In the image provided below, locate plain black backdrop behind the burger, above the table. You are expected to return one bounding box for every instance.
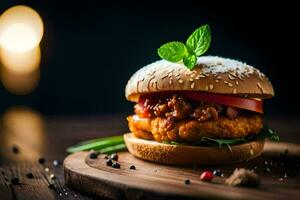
[0,0,300,115]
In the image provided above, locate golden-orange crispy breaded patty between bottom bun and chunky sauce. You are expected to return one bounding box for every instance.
[127,114,263,142]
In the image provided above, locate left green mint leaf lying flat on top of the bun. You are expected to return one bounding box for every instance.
[157,42,188,62]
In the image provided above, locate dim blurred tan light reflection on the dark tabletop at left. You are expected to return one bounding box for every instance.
[1,107,46,161]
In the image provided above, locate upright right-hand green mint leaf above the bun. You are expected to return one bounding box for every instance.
[186,24,211,56]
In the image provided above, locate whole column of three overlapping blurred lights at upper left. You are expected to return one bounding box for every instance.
[0,5,44,95]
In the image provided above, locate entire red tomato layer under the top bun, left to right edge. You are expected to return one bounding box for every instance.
[139,91,263,113]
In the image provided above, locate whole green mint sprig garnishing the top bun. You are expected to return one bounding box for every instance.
[157,24,211,70]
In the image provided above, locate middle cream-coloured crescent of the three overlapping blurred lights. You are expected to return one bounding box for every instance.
[0,46,41,74]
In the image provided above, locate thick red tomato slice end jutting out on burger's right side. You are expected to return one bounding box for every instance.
[180,91,264,113]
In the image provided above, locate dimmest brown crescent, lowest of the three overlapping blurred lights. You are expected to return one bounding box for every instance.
[1,64,40,95]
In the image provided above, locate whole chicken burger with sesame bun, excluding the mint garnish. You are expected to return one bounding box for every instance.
[124,56,274,165]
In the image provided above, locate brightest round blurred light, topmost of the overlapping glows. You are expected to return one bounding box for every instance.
[0,6,44,52]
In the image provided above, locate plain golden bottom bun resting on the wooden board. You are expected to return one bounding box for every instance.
[124,133,264,165]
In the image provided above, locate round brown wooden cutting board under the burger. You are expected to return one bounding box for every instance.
[64,145,300,199]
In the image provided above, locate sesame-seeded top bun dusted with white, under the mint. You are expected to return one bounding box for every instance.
[125,56,274,102]
